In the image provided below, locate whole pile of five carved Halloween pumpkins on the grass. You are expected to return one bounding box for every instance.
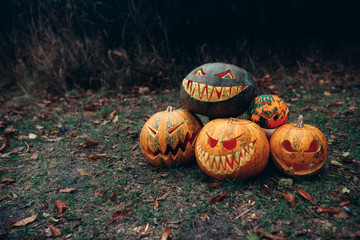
[140,63,328,180]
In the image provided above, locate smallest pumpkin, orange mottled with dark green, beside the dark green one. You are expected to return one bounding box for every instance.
[248,95,289,129]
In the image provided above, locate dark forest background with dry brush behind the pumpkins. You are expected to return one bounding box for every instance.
[0,0,360,94]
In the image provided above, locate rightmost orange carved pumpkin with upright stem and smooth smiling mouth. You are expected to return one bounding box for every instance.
[270,115,328,176]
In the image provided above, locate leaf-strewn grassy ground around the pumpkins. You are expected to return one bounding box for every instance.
[0,61,360,239]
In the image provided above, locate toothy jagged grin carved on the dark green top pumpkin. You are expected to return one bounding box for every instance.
[182,79,248,102]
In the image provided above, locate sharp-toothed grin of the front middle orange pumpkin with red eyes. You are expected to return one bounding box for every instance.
[195,140,256,174]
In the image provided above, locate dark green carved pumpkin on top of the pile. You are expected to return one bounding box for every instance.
[180,63,257,118]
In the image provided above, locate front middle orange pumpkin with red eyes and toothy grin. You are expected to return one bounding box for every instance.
[195,118,270,180]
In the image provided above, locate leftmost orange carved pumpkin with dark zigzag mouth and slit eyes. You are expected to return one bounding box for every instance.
[140,107,202,167]
